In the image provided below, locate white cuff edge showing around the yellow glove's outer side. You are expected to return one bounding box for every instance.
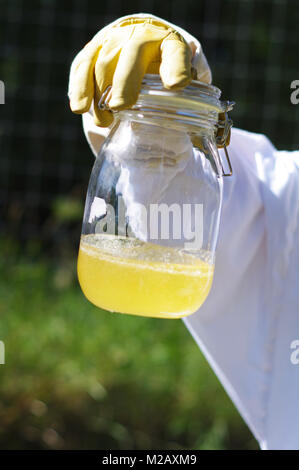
[82,13,212,156]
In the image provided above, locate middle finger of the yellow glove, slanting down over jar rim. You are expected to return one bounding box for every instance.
[109,40,159,110]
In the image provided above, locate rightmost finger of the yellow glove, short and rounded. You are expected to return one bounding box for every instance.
[160,31,192,89]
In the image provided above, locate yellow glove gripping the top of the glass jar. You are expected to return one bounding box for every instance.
[69,17,192,127]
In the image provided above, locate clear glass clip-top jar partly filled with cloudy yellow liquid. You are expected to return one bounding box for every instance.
[78,75,234,318]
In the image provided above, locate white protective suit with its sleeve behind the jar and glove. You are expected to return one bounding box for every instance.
[78,15,299,449]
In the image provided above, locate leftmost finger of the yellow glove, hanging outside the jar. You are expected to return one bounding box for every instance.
[69,38,101,114]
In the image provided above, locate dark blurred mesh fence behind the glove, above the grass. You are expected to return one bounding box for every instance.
[0,0,299,246]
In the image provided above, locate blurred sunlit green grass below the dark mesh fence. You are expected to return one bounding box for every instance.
[0,243,256,449]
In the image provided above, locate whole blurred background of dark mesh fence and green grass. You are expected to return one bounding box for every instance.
[0,0,299,449]
